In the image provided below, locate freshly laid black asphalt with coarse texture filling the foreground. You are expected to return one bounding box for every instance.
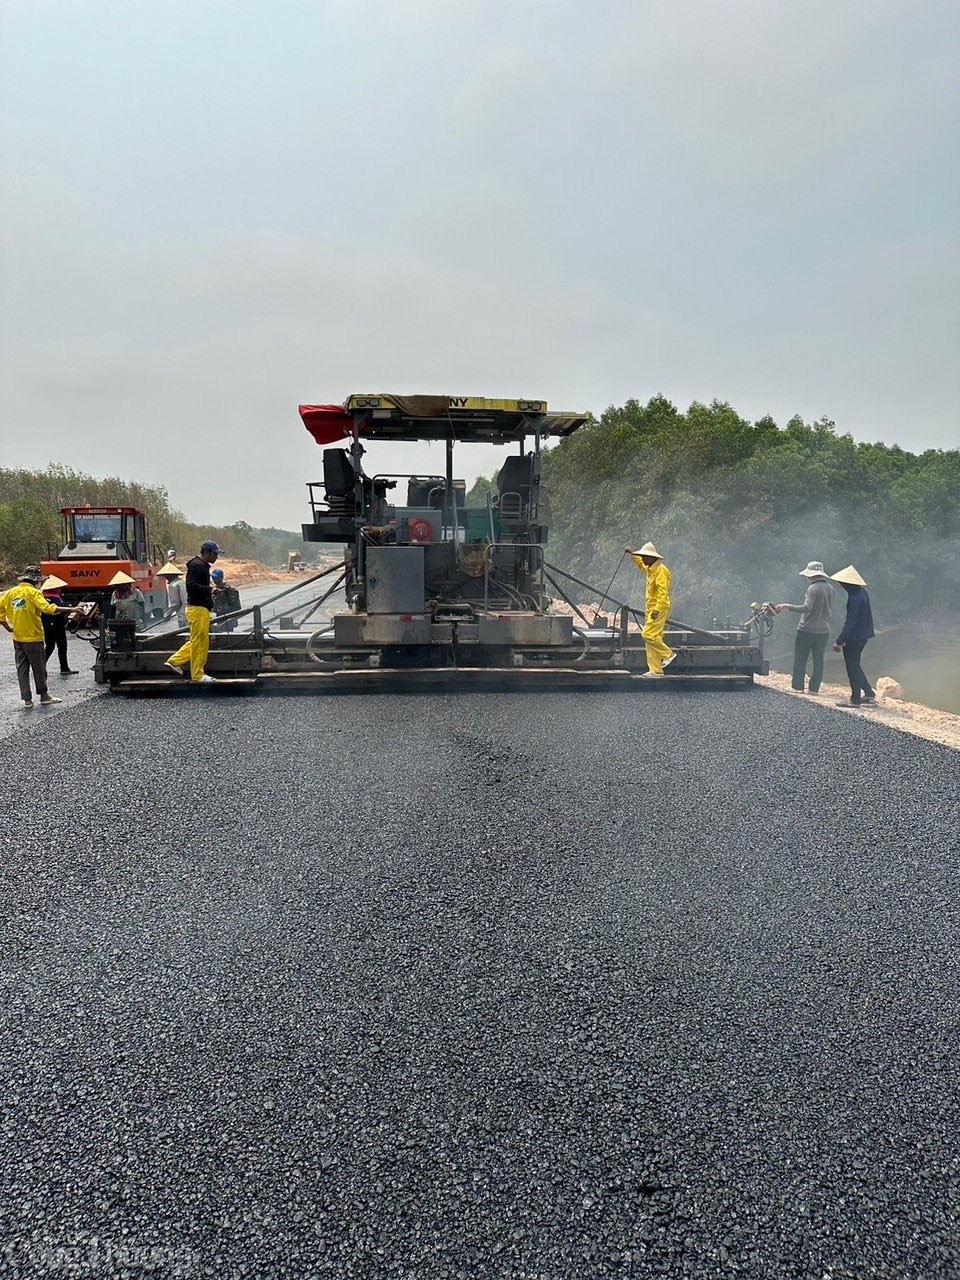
[0,687,960,1280]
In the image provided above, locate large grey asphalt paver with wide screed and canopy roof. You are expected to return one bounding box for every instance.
[97,394,767,692]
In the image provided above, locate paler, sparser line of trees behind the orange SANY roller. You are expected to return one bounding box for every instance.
[0,465,308,582]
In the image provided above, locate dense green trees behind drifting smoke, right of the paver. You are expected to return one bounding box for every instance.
[476,396,960,622]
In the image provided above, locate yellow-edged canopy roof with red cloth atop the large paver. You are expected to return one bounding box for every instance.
[300,396,589,444]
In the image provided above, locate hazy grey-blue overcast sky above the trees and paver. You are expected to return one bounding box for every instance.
[0,0,960,527]
